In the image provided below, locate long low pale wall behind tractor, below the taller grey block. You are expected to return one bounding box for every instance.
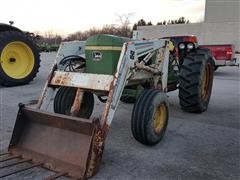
[138,22,240,49]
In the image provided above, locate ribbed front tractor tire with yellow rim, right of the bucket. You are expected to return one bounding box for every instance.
[131,89,168,145]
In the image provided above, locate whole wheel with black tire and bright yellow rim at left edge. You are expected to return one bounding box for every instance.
[0,31,40,86]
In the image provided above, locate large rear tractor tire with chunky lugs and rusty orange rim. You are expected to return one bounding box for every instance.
[179,49,214,113]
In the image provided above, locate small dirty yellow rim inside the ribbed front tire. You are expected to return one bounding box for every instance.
[153,104,167,134]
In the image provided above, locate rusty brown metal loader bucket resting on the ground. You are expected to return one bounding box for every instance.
[9,106,103,179]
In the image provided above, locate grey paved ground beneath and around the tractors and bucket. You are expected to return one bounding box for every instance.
[0,53,240,180]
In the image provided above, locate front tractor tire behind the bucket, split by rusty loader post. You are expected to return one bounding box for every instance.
[53,87,94,119]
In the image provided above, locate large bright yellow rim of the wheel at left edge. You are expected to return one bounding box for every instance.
[0,41,34,79]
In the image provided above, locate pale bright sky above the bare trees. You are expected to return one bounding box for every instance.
[0,0,205,35]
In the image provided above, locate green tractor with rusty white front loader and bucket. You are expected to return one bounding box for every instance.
[3,35,213,179]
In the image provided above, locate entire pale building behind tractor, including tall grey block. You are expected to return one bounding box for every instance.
[138,0,240,51]
